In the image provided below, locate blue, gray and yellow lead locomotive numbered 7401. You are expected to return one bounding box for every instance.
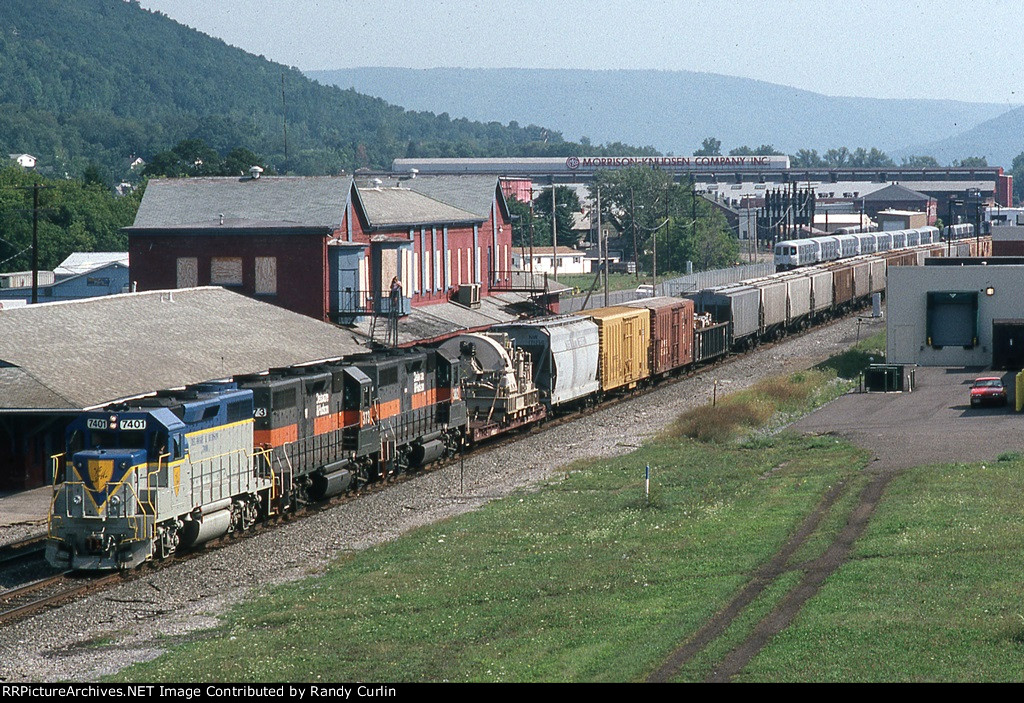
[46,383,274,569]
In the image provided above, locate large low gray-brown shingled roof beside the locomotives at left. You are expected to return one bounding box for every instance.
[0,288,366,408]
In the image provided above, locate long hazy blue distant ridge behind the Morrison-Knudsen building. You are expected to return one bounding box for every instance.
[304,68,1021,166]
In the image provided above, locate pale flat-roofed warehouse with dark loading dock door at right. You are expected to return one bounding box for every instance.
[886,258,1024,368]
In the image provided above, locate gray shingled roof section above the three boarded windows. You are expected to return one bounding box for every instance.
[128,176,352,230]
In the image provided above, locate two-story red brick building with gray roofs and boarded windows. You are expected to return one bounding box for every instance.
[125,175,512,322]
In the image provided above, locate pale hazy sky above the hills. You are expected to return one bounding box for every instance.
[141,0,1024,104]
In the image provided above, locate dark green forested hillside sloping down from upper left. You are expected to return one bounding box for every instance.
[0,0,653,182]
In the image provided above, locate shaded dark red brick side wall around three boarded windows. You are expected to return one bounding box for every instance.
[128,233,328,320]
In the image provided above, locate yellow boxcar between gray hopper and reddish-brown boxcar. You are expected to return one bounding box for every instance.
[587,306,650,392]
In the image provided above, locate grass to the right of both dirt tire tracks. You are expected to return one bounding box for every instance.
[741,458,1024,682]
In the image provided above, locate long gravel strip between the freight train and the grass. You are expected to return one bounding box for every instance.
[0,319,884,683]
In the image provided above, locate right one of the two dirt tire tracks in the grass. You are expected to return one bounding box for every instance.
[707,470,903,683]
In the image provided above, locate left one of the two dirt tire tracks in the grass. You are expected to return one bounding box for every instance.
[647,481,847,684]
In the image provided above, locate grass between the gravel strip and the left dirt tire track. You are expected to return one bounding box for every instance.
[114,438,863,680]
